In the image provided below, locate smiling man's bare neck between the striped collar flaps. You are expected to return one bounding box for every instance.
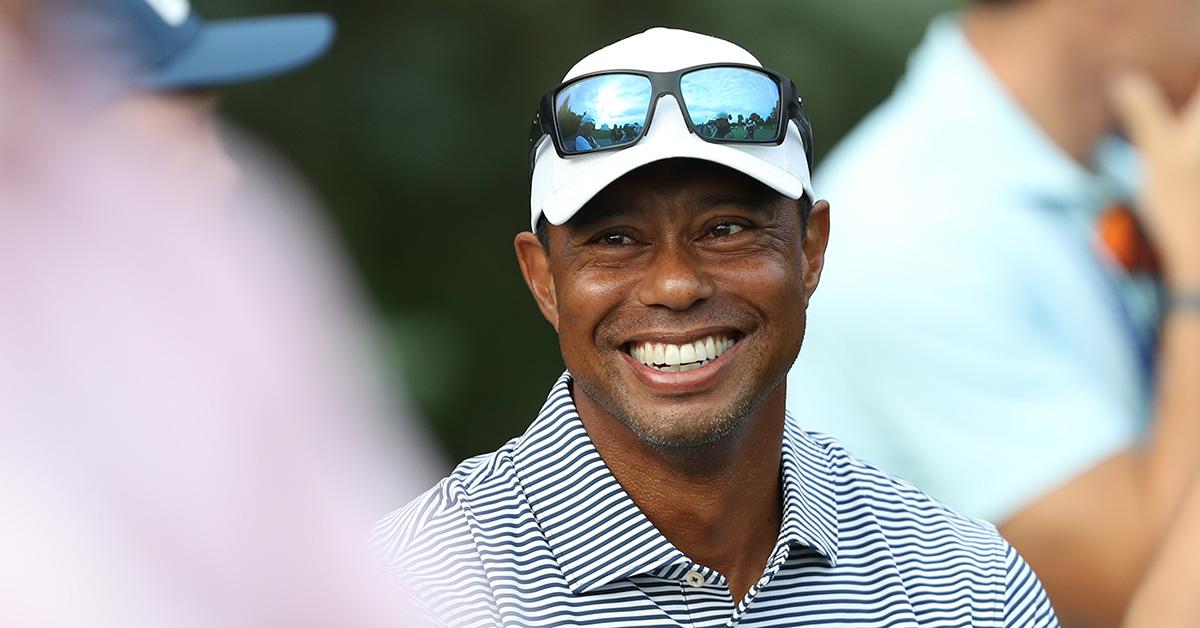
[575,384,785,602]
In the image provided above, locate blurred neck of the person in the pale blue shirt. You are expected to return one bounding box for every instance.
[962,2,1114,166]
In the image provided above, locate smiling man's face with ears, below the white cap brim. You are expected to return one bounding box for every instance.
[517,160,828,447]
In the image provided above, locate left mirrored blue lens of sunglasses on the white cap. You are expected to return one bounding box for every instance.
[554,74,650,155]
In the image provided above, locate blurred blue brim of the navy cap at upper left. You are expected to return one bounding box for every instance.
[143,13,336,89]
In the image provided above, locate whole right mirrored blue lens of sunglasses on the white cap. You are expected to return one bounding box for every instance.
[679,67,782,142]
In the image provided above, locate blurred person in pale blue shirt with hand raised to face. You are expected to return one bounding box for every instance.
[791,0,1200,626]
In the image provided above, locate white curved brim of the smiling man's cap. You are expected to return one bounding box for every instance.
[541,135,812,225]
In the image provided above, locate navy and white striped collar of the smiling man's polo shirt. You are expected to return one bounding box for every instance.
[512,372,838,593]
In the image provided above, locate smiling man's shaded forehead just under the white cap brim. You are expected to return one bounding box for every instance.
[564,159,791,229]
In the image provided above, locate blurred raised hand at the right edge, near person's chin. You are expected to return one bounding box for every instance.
[1111,73,1200,292]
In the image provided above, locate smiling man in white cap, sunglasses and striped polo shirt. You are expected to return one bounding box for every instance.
[374,29,1056,627]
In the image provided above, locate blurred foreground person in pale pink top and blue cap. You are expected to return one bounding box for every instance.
[0,0,439,628]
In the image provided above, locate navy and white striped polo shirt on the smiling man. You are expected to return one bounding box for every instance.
[372,373,1057,627]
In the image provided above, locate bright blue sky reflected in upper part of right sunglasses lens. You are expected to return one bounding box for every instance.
[679,67,779,124]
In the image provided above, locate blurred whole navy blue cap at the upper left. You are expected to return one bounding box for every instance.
[60,0,335,90]
